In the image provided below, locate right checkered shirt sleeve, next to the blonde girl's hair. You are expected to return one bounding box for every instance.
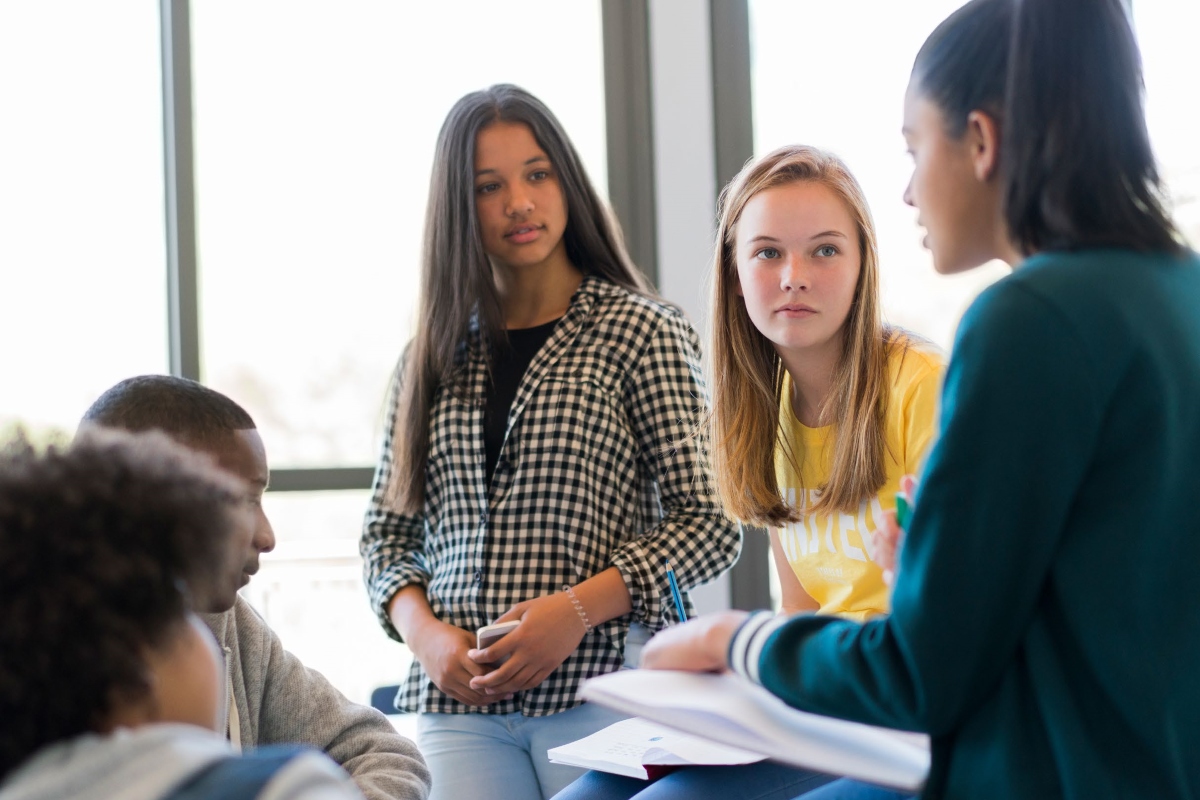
[612,313,742,630]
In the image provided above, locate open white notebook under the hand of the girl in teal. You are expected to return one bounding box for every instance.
[576,669,929,792]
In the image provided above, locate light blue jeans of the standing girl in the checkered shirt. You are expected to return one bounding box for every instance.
[416,703,626,800]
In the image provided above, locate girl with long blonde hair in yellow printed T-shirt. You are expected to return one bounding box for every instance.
[559,146,942,800]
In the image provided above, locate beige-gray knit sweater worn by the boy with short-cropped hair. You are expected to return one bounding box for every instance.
[238,606,430,800]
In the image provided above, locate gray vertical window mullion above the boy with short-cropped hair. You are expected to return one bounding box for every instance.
[158,0,200,380]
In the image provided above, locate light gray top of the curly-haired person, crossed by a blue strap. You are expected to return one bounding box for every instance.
[0,723,362,800]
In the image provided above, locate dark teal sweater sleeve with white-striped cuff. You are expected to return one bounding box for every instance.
[748,281,1103,735]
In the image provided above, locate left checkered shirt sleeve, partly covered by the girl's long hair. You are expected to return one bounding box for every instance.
[359,350,430,642]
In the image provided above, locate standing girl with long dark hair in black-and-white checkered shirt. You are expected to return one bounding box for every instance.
[361,85,740,800]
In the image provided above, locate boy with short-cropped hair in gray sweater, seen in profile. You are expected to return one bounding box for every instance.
[80,375,430,800]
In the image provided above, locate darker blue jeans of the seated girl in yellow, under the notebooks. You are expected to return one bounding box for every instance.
[554,762,833,800]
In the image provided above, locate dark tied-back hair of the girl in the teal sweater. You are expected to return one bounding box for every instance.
[912,0,1182,254]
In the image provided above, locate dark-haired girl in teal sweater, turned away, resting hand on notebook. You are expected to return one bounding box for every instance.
[643,0,1200,799]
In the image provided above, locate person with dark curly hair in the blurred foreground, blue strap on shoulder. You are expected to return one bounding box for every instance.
[0,432,361,800]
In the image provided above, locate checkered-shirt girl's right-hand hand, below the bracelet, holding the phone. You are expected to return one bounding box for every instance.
[467,591,586,696]
